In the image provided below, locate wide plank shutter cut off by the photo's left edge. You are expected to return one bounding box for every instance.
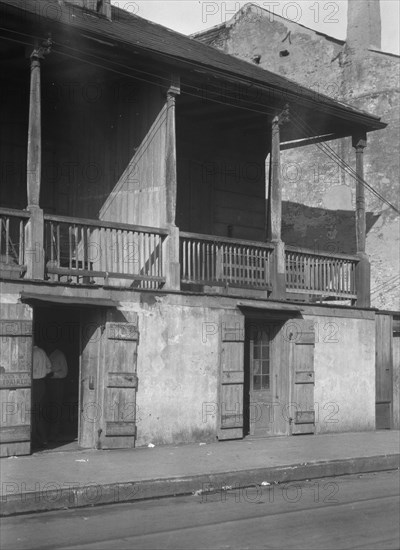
[0,304,33,457]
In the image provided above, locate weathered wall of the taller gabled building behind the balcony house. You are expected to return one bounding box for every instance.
[195,4,400,310]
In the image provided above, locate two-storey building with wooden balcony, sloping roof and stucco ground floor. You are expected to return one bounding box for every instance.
[0,0,399,456]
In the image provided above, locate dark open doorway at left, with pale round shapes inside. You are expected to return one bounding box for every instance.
[32,304,80,451]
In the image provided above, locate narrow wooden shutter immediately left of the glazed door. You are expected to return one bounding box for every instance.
[218,315,244,439]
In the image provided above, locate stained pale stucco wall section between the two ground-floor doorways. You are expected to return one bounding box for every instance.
[122,298,223,446]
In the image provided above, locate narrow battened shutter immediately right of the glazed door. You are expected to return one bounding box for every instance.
[287,319,315,435]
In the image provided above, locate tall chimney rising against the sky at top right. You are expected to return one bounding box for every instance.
[347,0,381,53]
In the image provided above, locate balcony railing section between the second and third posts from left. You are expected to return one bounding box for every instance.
[180,233,273,289]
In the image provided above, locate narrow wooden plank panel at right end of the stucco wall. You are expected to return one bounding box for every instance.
[375,315,393,430]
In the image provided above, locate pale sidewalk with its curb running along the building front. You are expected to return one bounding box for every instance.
[0,431,400,515]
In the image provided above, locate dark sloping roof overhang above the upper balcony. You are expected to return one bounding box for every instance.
[0,0,386,140]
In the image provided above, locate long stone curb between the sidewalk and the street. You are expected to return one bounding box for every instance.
[0,454,400,517]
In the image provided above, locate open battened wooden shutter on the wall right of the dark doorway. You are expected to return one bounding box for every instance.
[100,321,139,449]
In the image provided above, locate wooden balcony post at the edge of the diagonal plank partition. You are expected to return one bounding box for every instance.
[164,75,180,290]
